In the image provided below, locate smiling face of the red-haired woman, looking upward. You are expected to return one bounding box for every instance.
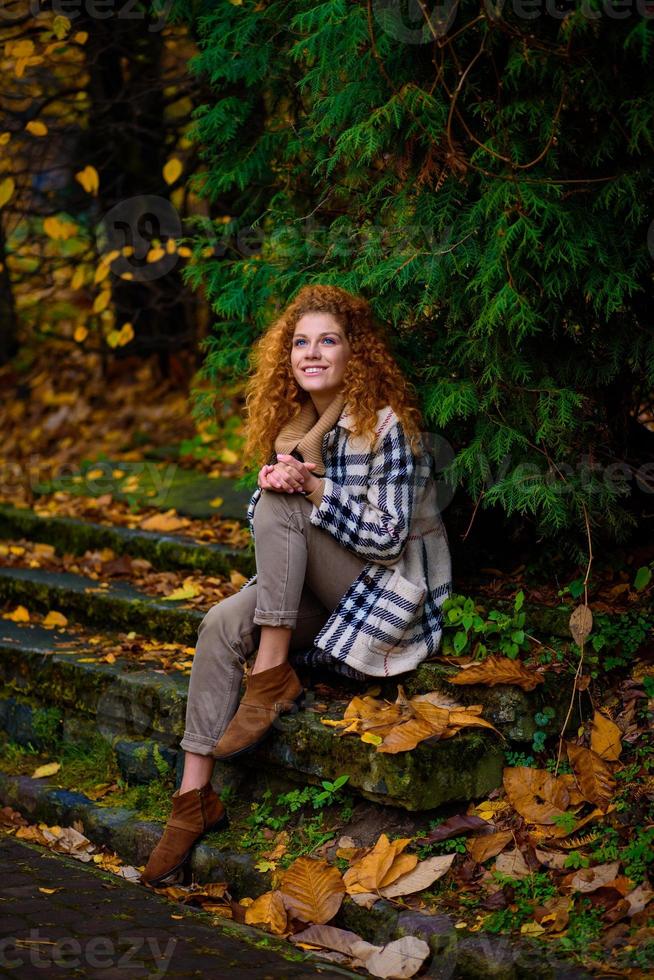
[291,313,352,411]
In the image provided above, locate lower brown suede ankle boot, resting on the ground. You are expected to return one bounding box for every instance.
[141,782,227,888]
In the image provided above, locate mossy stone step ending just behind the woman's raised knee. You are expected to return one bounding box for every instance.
[0,504,256,578]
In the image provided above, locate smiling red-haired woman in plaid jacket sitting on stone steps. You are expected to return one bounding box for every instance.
[141,286,451,885]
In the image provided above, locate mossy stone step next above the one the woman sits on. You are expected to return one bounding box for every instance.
[0,568,204,646]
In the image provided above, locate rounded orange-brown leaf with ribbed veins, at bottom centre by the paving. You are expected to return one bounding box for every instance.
[279,857,345,925]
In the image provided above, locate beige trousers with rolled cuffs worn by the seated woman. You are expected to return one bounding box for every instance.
[179,490,366,755]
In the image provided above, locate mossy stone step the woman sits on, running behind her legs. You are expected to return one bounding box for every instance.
[0,621,507,810]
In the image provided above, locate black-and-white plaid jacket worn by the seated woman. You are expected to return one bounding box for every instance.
[242,405,452,677]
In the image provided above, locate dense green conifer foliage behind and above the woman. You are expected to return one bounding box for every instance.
[174,0,654,538]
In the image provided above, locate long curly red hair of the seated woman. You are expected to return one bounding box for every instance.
[244,285,422,467]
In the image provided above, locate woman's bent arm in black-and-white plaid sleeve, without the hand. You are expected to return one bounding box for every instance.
[310,423,416,565]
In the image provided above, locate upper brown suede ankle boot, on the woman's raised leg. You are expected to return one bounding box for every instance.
[211,661,304,759]
